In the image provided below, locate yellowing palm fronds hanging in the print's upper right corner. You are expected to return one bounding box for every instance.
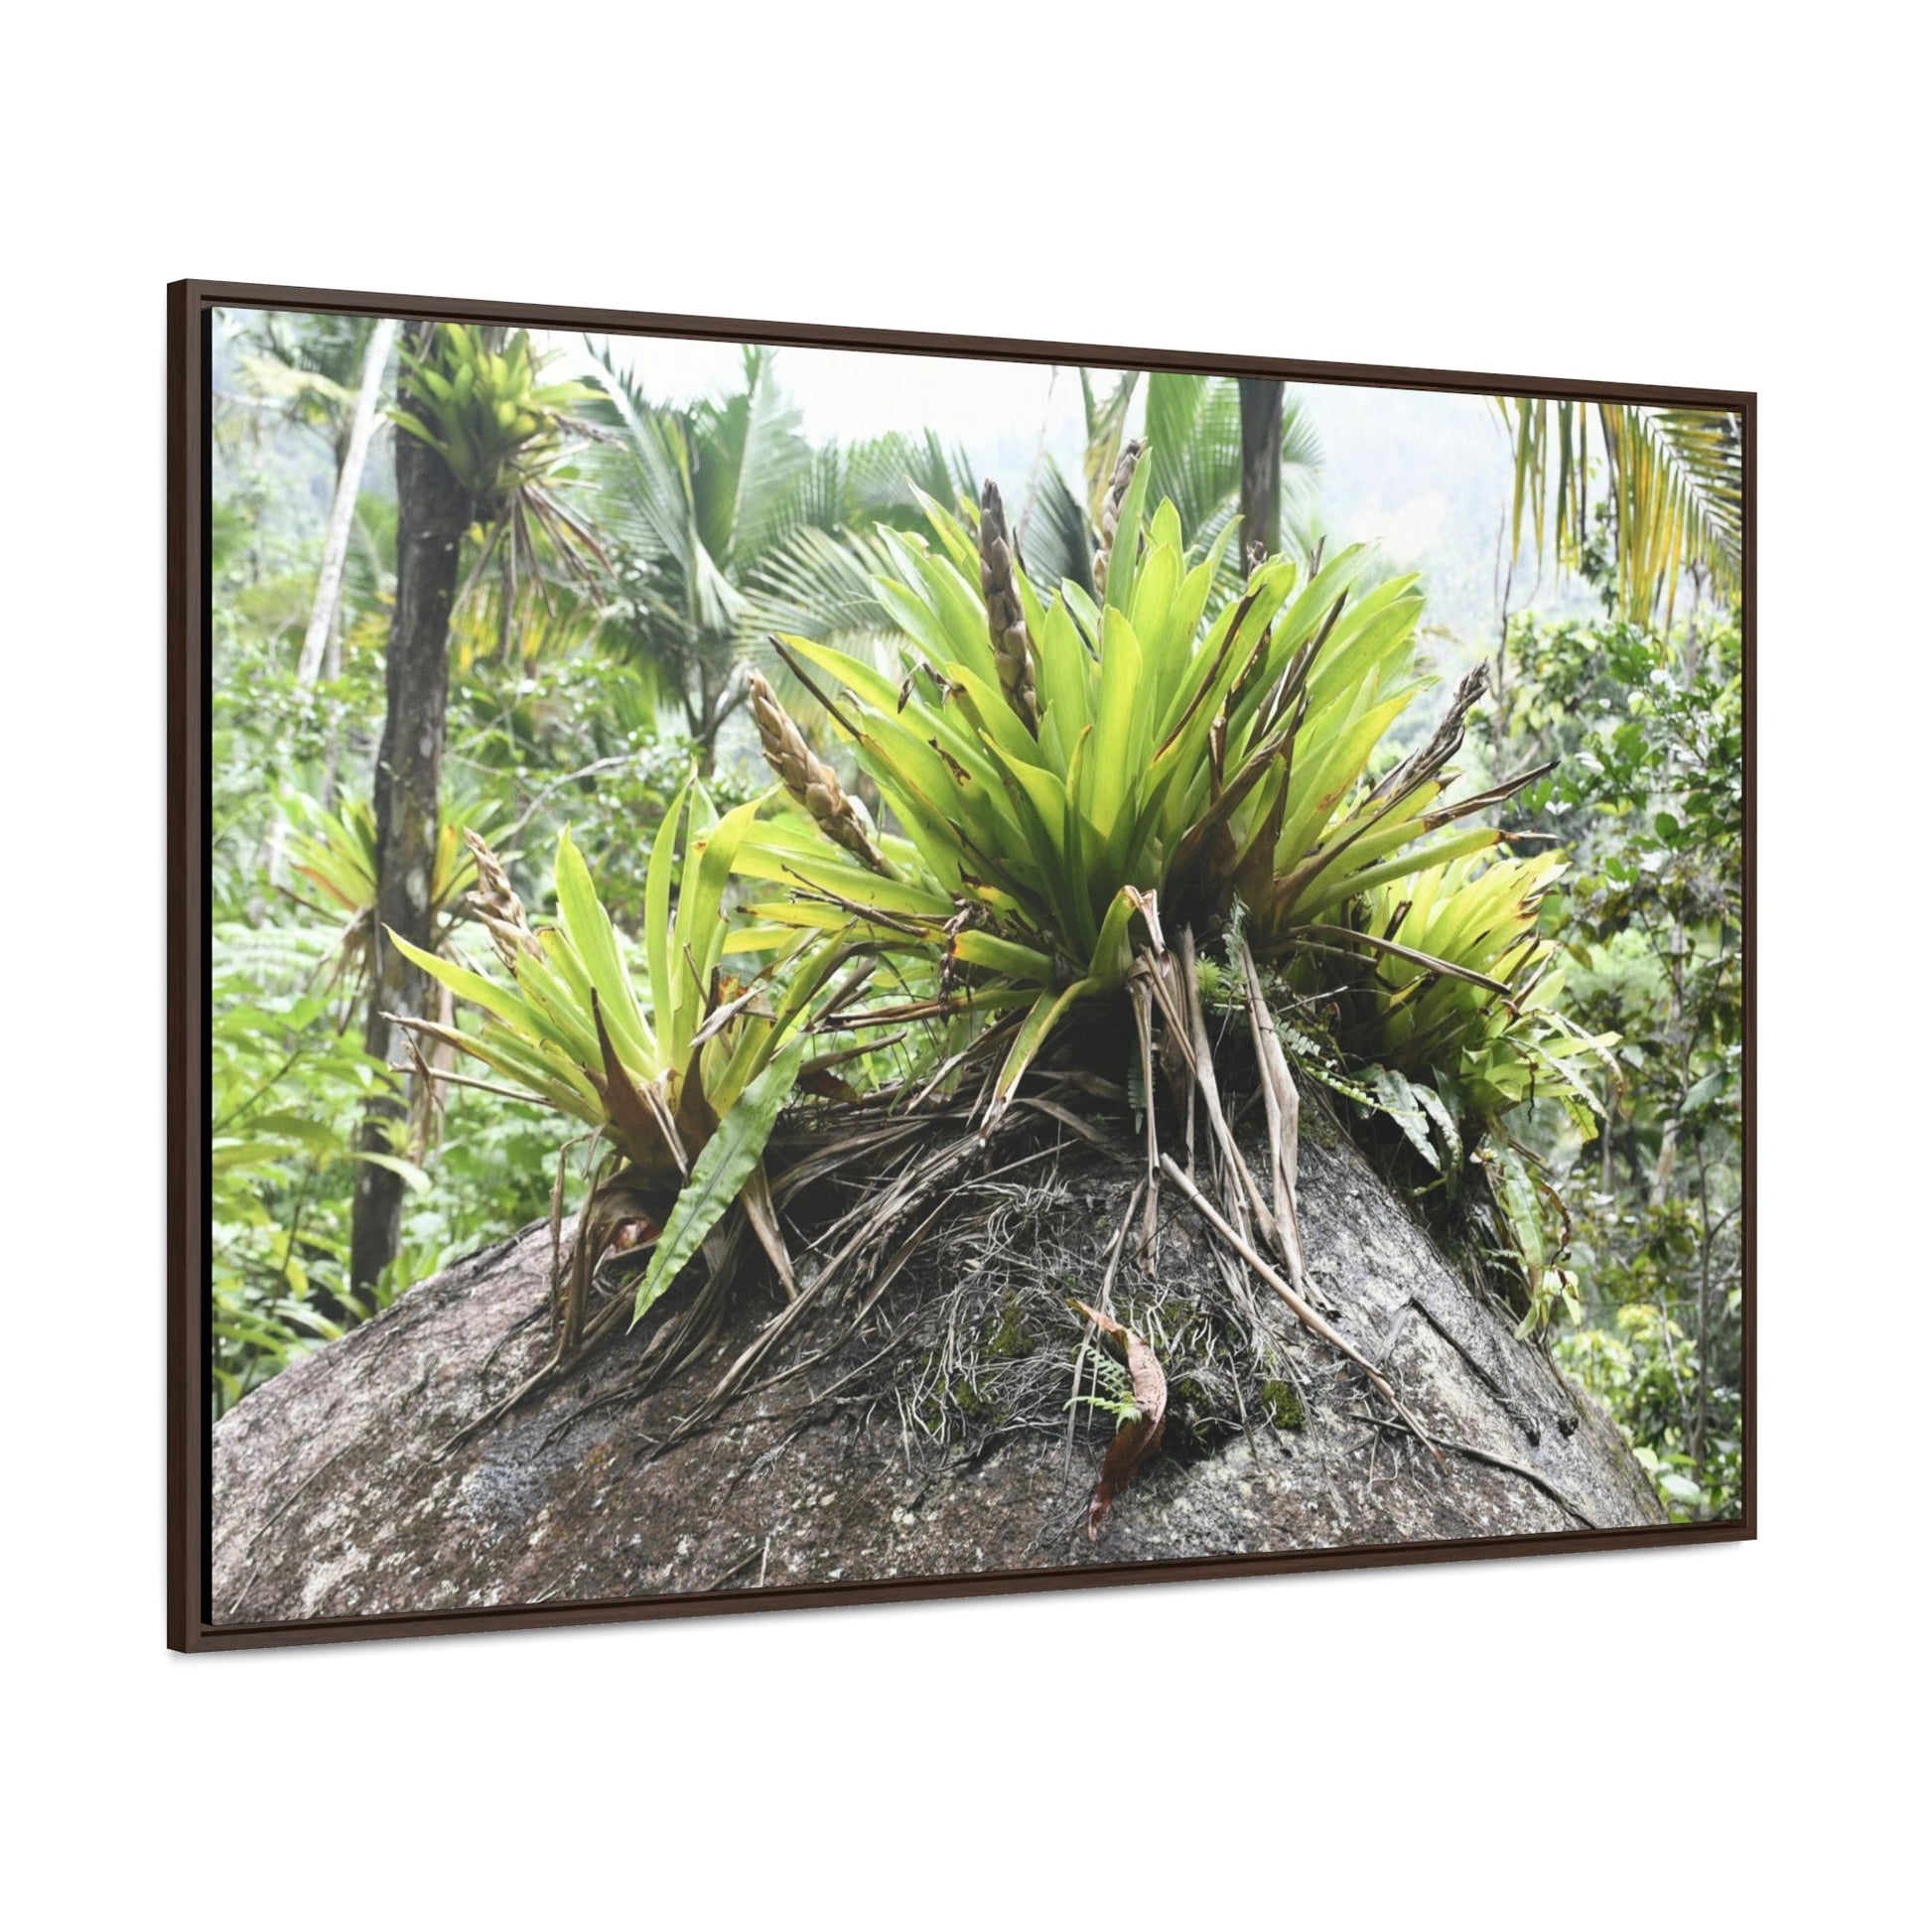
[1497,396,1744,626]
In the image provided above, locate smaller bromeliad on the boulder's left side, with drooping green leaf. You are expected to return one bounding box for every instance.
[390,782,839,1428]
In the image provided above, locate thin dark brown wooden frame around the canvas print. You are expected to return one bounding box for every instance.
[166,280,1758,1652]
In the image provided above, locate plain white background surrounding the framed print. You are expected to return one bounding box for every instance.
[0,0,1932,1928]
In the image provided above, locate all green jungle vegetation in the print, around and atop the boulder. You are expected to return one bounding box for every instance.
[210,315,1744,1526]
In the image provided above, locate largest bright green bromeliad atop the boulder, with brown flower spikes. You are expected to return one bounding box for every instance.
[740,445,1538,1127]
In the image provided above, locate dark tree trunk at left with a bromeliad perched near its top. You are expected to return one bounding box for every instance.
[349,338,472,1287]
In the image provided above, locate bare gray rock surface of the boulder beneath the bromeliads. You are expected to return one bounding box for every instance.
[212,1140,1664,1623]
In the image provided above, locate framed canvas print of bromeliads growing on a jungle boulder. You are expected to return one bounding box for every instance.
[168,282,1754,1650]
